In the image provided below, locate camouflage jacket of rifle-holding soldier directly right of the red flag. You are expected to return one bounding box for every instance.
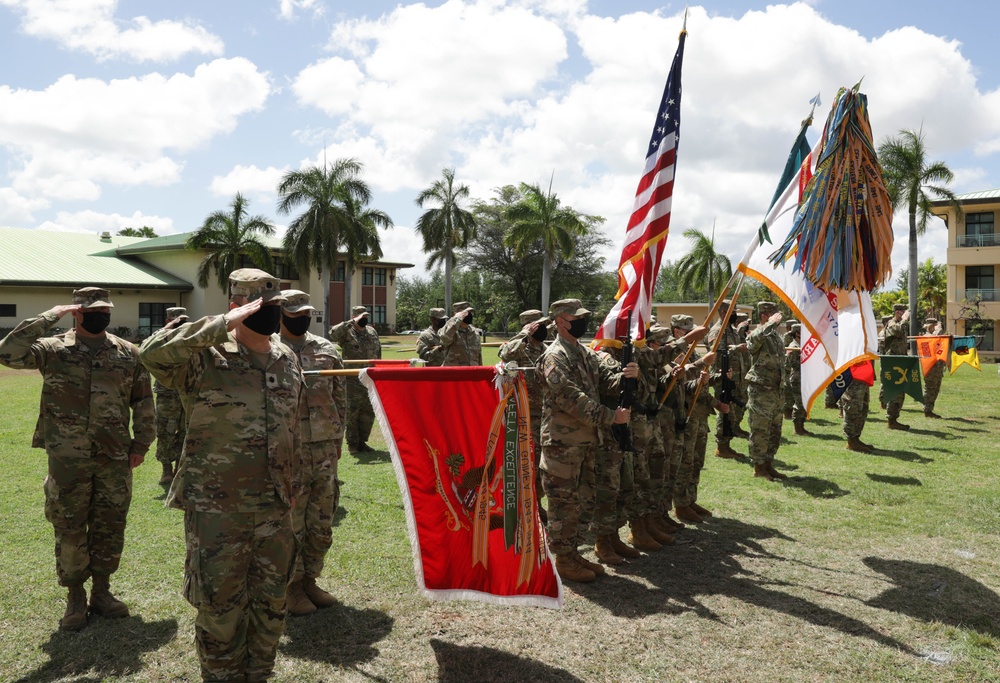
[535,337,621,446]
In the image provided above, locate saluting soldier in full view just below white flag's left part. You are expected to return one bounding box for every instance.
[747,301,787,481]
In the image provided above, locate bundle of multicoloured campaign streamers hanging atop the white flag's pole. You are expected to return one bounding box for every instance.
[768,83,893,291]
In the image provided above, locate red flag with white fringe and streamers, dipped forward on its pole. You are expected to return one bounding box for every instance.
[360,367,563,608]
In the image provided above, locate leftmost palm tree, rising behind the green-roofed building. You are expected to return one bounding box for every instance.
[187,192,274,292]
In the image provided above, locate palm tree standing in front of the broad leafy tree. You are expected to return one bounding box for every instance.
[504,180,586,311]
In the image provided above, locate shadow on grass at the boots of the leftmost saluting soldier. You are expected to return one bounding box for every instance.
[15,616,177,683]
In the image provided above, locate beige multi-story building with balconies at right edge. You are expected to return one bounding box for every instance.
[931,189,1000,358]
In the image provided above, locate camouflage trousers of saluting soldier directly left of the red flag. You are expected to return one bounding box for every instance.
[292,440,341,580]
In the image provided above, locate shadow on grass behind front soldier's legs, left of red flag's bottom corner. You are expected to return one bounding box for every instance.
[278,602,394,675]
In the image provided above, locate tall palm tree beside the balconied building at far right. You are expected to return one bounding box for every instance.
[878,129,962,344]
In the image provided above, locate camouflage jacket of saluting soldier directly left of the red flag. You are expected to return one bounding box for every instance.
[279,332,348,443]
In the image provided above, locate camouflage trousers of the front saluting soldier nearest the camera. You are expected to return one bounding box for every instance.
[184,505,295,681]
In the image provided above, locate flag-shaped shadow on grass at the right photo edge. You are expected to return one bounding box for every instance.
[864,557,1000,637]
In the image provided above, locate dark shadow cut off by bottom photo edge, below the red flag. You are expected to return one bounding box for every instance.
[431,638,583,683]
